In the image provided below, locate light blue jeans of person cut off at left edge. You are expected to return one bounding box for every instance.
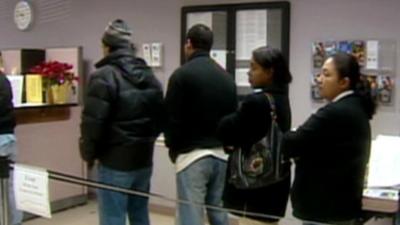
[0,134,23,225]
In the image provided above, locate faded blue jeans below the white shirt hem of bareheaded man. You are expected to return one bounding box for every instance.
[176,157,229,225]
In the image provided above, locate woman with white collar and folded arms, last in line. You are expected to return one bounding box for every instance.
[282,53,376,225]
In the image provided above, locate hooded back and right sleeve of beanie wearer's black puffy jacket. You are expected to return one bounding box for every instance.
[93,50,164,170]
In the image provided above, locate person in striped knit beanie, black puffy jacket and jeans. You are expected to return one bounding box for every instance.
[81,20,164,225]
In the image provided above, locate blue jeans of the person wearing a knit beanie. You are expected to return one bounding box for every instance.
[97,165,152,225]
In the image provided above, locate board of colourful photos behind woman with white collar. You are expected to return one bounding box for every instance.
[310,39,397,107]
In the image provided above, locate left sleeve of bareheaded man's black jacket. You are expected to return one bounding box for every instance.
[164,72,185,149]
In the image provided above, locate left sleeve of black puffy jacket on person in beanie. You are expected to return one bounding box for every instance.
[80,75,115,162]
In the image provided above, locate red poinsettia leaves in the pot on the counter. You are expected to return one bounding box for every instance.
[29,61,78,85]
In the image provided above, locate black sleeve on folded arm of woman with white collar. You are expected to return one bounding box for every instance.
[282,106,335,158]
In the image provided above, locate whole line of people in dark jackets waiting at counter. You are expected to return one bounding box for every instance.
[0,19,376,225]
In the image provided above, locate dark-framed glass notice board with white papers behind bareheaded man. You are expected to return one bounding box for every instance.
[181,1,290,96]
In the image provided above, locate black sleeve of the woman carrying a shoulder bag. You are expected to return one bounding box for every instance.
[217,96,271,146]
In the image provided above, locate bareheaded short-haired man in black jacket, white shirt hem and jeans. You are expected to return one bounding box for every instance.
[165,25,237,225]
